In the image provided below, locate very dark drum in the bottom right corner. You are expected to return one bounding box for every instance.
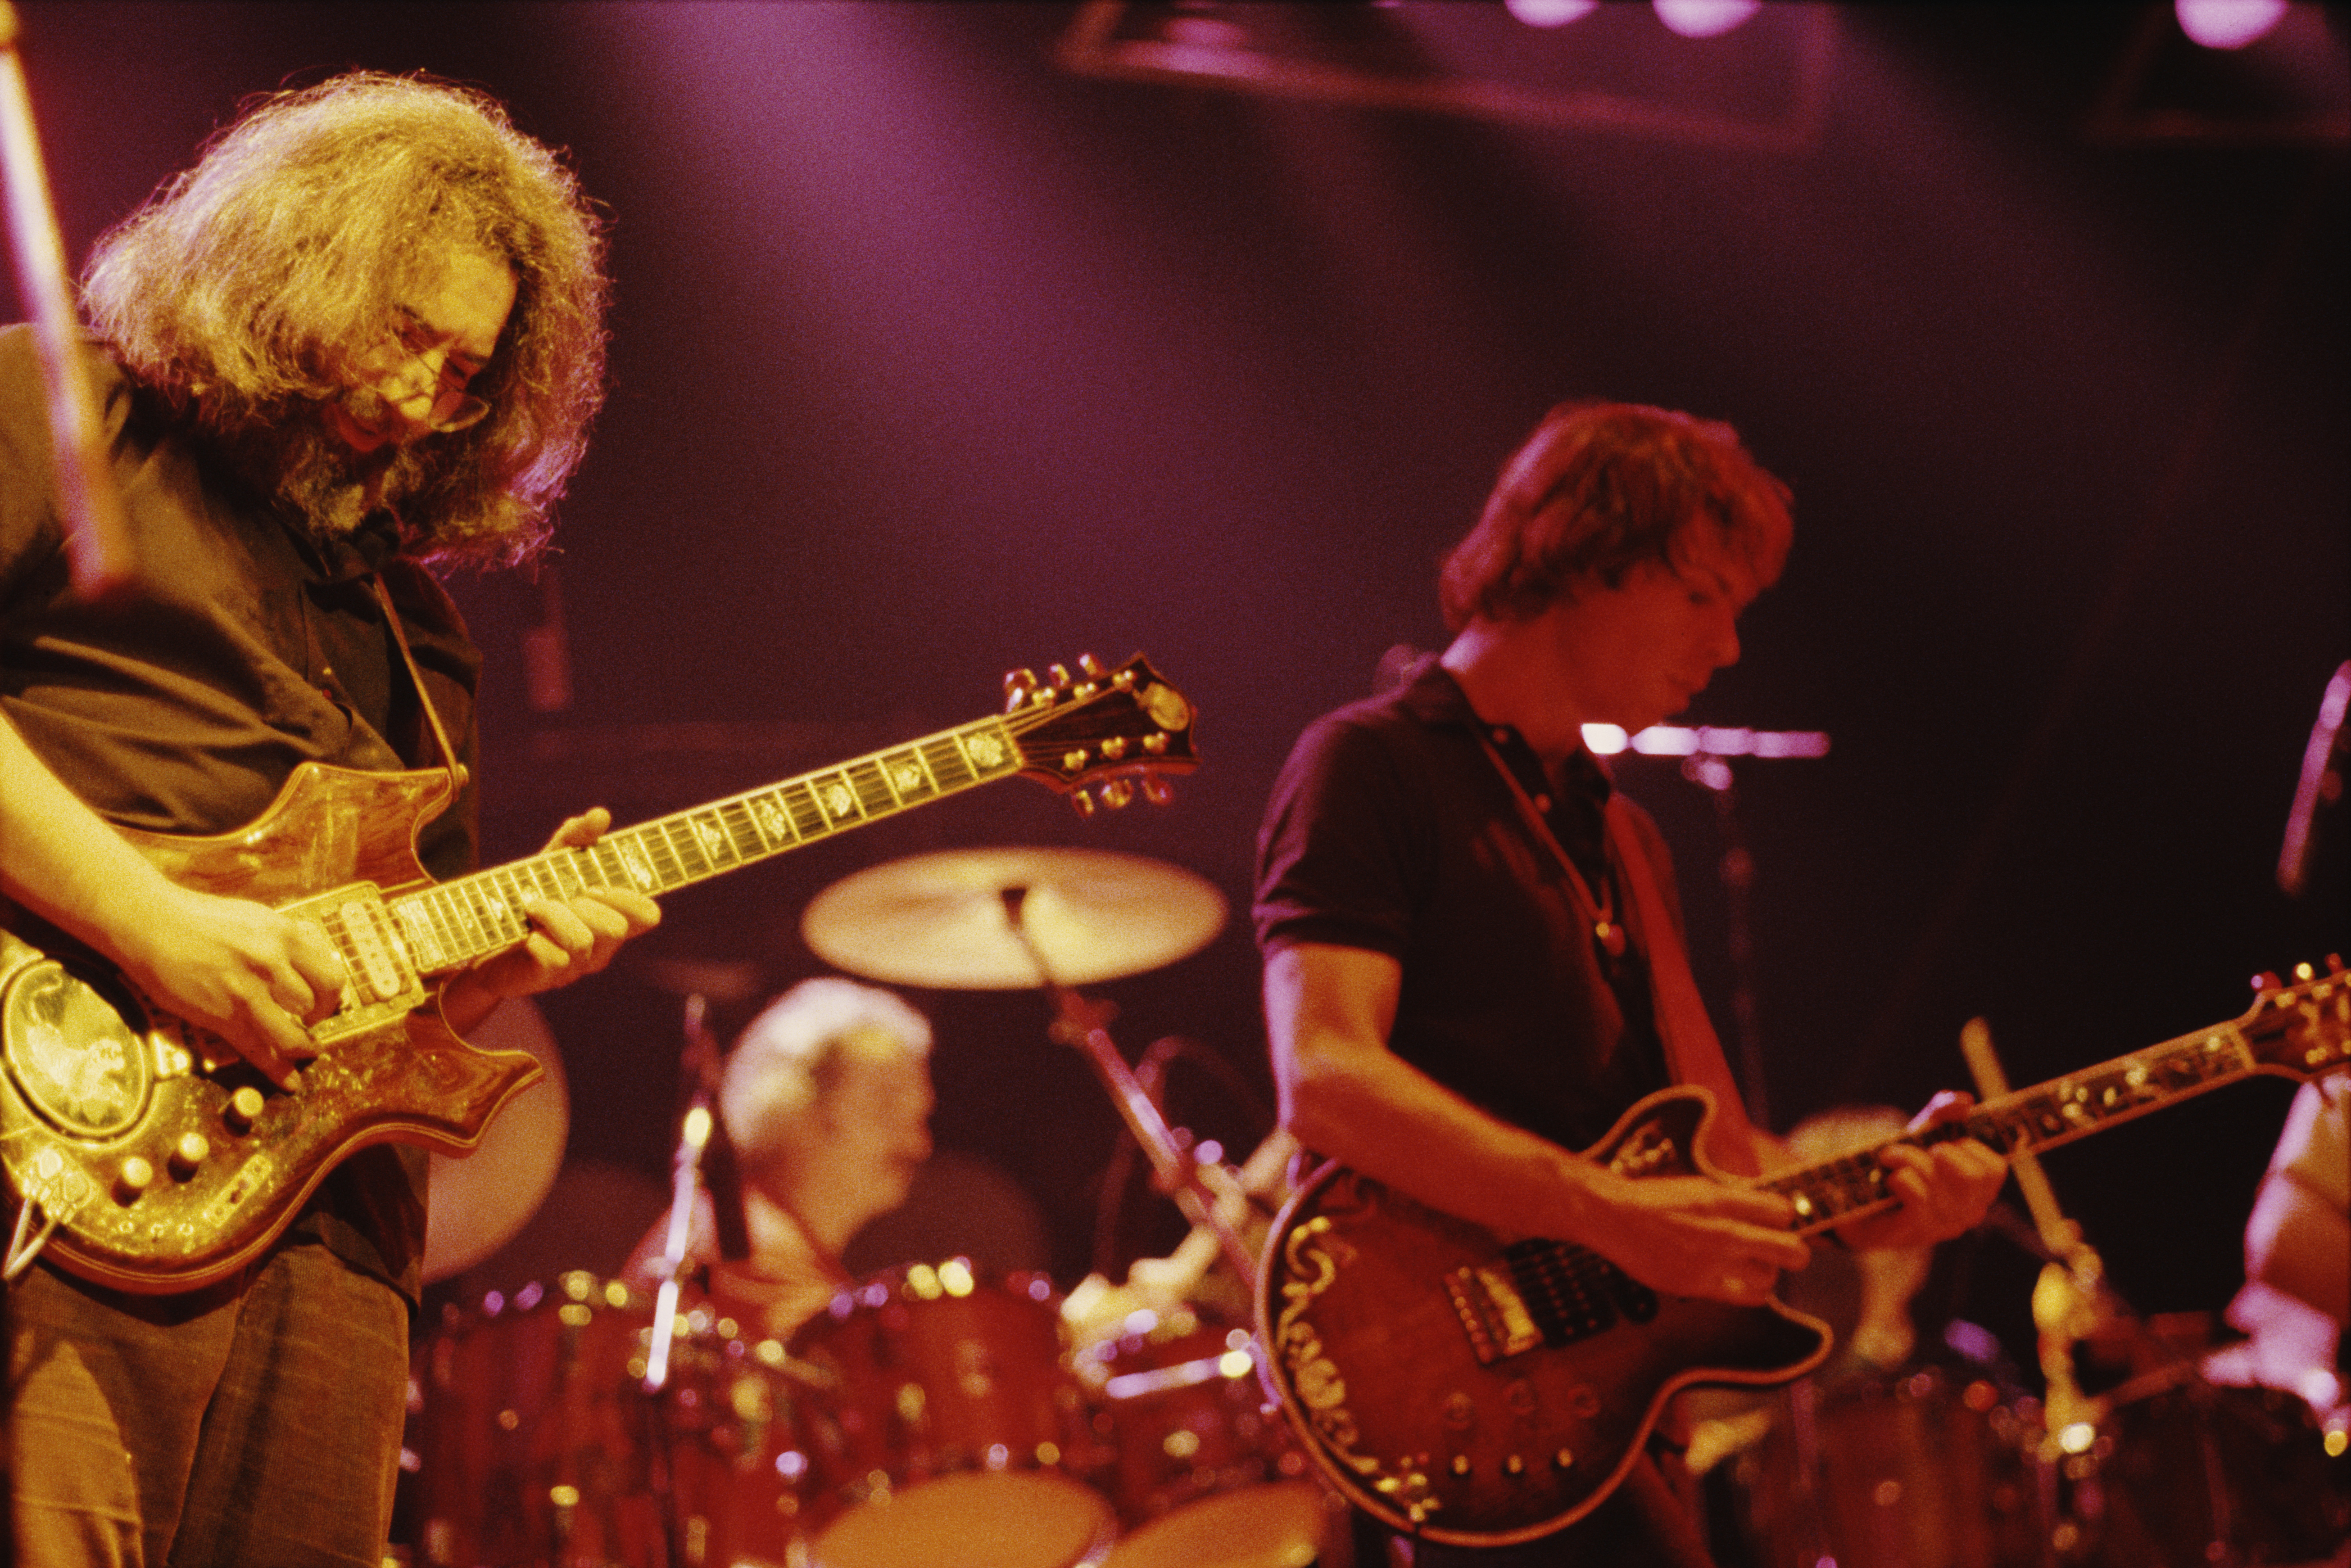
[2060,1382,2351,1568]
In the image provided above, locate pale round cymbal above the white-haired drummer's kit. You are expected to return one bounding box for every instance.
[799,846,1225,990]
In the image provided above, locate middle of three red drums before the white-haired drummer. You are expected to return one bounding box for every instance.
[780,1258,1114,1568]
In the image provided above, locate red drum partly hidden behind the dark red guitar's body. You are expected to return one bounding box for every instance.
[1077,1307,1333,1568]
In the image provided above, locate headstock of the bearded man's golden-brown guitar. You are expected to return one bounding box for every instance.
[1004,654,1199,816]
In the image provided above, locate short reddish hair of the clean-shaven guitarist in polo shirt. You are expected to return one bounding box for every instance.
[1439,402,1794,633]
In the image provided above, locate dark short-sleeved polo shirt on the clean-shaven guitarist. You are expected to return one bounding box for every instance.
[1255,658,1679,1150]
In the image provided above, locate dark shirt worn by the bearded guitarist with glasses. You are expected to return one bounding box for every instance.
[0,327,480,1300]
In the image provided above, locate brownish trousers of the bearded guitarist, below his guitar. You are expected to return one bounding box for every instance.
[7,1241,409,1568]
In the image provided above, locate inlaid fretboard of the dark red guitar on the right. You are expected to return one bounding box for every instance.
[1756,1023,2255,1234]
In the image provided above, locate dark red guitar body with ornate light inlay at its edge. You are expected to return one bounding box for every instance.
[1258,1089,1829,1547]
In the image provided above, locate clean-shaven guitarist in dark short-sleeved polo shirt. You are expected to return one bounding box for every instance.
[1255,402,2006,1568]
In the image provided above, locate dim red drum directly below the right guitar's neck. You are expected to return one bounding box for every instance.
[1733,1366,2047,1568]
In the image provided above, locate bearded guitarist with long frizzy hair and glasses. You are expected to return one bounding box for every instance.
[0,73,656,1568]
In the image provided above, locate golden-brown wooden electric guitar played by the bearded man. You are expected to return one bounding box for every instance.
[0,656,1196,1293]
